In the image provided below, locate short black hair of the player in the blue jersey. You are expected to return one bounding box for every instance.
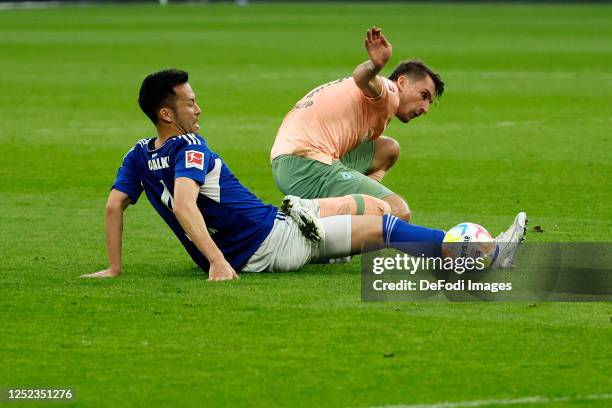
[138,69,189,125]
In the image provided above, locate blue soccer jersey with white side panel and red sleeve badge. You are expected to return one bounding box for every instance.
[113,134,278,270]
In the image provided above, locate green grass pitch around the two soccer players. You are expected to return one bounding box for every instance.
[0,4,612,407]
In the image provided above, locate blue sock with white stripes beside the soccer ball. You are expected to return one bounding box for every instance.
[383,214,445,257]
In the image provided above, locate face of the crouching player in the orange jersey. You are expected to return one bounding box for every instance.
[395,75,436,123]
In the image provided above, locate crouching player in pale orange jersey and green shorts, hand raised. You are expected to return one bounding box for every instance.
[271,27,444,221]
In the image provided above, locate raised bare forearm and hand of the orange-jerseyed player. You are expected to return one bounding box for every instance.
[353,27,392,98]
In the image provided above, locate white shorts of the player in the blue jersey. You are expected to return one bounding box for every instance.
[242,215,351,272]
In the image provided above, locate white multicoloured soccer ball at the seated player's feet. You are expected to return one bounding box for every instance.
[442,222,497,267]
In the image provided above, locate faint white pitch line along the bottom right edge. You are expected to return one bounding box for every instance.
[372,394,612,408]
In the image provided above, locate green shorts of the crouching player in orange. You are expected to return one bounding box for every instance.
[272,151,395,199]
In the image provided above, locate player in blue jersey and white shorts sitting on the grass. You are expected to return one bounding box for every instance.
[83,69,526,281]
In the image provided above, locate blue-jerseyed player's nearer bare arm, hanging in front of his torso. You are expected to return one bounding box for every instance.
[173,177,239,281]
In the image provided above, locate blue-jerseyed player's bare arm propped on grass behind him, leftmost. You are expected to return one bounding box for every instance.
[81,189,131,278]
